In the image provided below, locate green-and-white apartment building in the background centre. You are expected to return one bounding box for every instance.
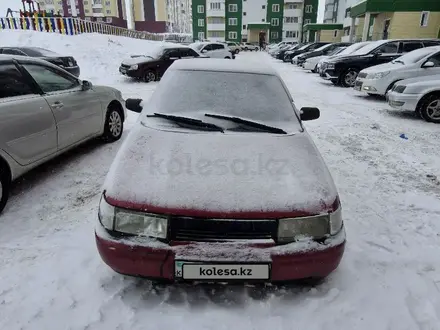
[192,0,318,42]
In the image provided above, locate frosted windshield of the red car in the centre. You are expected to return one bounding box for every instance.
[144,70,301,130]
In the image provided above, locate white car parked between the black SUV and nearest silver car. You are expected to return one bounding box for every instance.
[354,46,440,96]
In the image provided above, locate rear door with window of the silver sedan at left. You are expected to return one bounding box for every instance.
[0,61,57,166]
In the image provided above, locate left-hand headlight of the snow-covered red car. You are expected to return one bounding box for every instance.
[98,195,168,239]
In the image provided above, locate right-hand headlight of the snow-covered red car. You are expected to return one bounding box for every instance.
[278,206,343,243]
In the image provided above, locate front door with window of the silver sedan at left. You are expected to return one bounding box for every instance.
[21,63,104,150]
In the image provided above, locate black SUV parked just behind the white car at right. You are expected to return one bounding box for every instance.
[320,39,440,87]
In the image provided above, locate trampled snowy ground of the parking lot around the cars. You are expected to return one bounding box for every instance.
[0,31,440,330]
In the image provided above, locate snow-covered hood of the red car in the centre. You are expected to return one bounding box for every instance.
[103,121,337,217]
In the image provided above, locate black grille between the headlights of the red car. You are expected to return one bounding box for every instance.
[170,217,278,242]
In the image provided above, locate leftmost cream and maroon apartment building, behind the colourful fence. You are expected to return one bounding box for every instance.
[37,0,127,28]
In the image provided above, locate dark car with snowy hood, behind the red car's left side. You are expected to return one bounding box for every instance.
[119,45,207,82]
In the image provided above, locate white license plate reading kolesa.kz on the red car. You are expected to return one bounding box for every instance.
[175,261,270,281]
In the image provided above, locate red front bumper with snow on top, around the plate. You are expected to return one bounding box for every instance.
[95,224,345,282]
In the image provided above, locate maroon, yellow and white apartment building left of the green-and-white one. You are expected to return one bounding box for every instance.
[132,0,192,33]
